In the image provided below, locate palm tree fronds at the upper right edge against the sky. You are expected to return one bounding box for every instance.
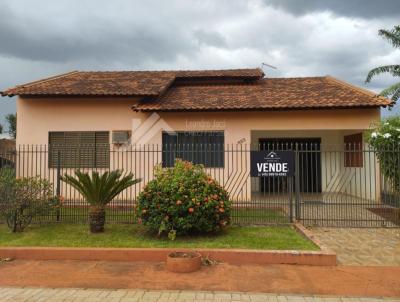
[365,25,400,103]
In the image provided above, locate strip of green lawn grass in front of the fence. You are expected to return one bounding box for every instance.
[0,223,318,250]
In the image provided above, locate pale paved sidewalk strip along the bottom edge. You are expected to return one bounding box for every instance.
[0,287,400,302]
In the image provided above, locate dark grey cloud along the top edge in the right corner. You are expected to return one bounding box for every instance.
[265,0,400,18]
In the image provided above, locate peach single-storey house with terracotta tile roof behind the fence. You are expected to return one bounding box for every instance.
[1,69,391,205]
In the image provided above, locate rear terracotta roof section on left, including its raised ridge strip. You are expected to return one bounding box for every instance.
[1,69,264,96]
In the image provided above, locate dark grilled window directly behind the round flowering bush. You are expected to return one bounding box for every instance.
[162,131,224,168]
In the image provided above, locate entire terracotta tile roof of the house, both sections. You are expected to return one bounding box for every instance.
[1,69,392,111]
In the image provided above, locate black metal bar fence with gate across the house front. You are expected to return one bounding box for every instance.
[0,142,400,227]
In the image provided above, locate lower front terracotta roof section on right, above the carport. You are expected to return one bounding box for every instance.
[133,76,391,111]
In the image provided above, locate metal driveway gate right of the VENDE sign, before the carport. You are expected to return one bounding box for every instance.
[295,145,400,227]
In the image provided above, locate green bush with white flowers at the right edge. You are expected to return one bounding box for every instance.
[367,116,400,192]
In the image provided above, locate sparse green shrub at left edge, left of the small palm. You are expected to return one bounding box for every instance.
[0,168,59,232]
